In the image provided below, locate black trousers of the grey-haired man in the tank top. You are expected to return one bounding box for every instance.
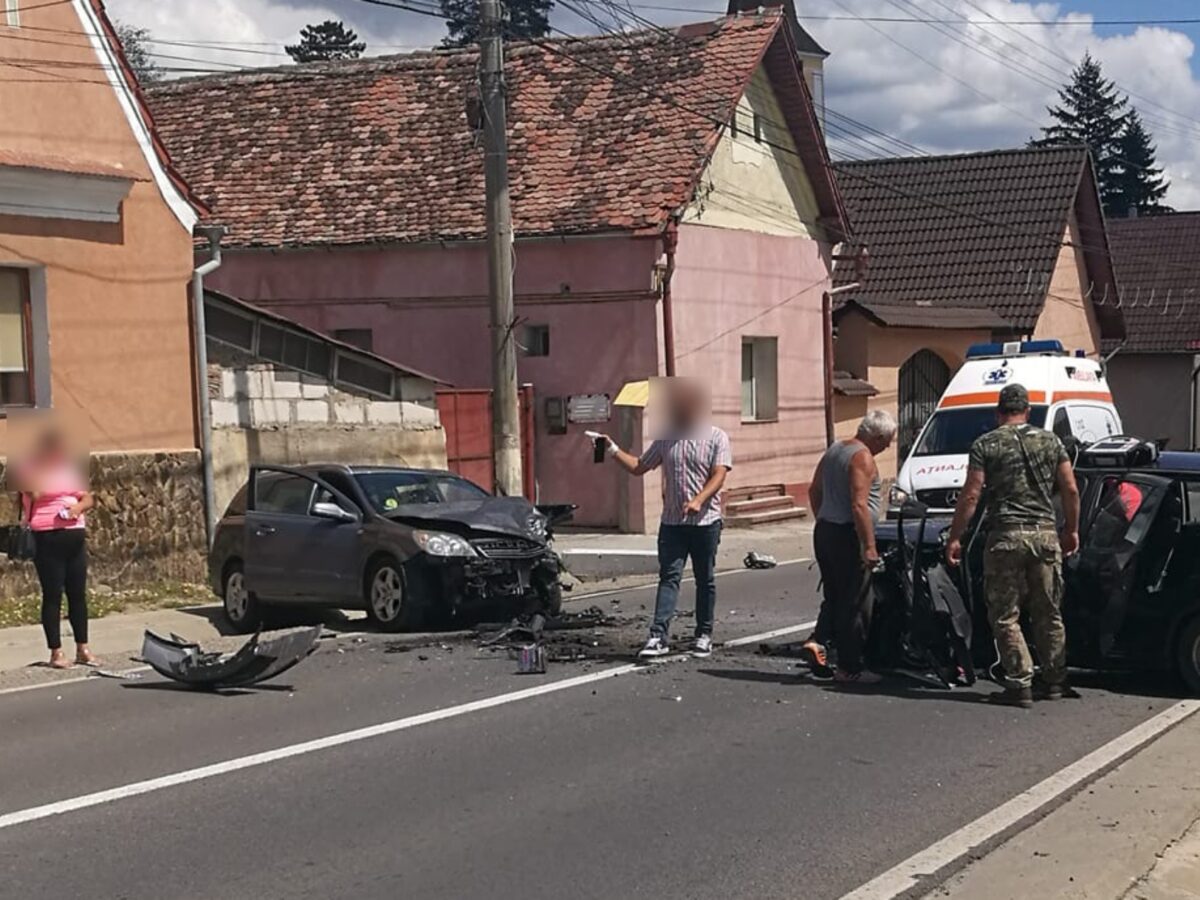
[812,522,871,672]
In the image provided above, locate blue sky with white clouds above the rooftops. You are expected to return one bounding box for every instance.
[107,0,1200,209]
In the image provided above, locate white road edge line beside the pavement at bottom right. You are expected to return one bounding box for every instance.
[841,700,1200,900]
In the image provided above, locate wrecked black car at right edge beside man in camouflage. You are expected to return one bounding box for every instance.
[875,438,1200,694]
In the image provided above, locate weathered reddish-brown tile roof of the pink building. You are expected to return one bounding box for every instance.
[142,11,841,252]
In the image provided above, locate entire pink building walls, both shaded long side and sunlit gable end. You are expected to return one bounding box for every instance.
[209,226,829,530]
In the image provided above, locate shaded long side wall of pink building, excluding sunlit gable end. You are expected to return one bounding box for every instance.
[209,238,661,528]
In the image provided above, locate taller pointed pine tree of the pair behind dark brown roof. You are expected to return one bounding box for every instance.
[1030,53,1129,215]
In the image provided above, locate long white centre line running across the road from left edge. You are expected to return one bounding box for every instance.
[0,625,805,830]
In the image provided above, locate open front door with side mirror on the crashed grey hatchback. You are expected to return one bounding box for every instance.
[245,466,362,602]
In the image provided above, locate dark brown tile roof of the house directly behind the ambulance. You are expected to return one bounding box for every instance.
[836,146,1120,335]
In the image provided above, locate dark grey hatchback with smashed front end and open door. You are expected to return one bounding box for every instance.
[209,466,574,631]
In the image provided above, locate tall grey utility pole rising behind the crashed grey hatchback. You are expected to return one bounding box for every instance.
[479,0,522,497]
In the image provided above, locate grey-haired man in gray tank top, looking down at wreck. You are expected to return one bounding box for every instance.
[804,409,896,684]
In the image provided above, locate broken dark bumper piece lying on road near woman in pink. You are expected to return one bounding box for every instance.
[142,625,320,690]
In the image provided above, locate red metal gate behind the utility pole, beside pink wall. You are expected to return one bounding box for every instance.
[438,384,538,500]
